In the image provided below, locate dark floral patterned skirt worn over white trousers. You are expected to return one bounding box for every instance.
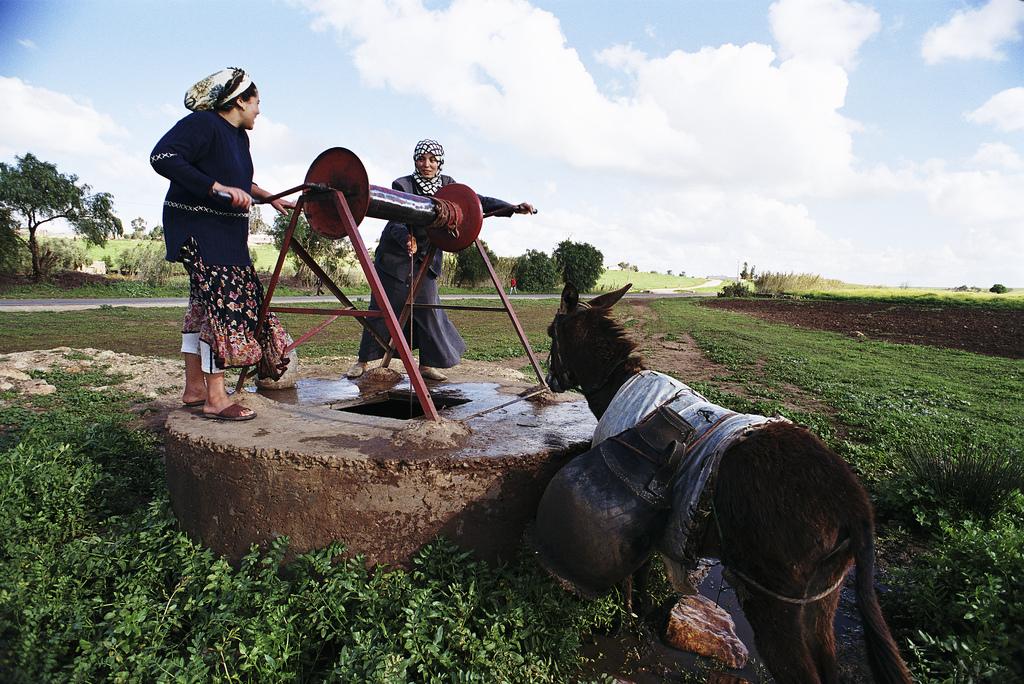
[178,239,292,380]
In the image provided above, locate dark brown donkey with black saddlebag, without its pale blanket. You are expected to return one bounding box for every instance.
[537,285,910,683]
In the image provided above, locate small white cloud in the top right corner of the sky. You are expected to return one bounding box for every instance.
[921,0,1024,65]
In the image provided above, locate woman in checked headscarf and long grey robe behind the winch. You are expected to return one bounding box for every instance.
[346,139,536,380]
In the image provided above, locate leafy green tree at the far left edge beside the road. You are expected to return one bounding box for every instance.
[0,153,124,281]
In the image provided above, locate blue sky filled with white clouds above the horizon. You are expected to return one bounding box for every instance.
[0,0,1024,288]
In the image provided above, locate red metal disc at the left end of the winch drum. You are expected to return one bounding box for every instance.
[303,147,370,240]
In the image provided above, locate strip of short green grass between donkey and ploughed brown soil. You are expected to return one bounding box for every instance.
[652,300,1024,464]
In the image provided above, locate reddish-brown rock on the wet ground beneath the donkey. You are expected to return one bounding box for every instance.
[665,594,750,669]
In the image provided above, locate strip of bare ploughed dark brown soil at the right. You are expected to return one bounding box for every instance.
[705,299,1024,358]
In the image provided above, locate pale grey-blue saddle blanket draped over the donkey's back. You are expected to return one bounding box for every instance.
[592,371,785,567]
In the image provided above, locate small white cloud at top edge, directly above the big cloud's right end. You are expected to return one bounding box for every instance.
[768,0,882,70]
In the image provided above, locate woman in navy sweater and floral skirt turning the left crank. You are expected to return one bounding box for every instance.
[150,69,294,421]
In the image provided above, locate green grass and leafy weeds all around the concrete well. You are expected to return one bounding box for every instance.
[0,300,1024,682]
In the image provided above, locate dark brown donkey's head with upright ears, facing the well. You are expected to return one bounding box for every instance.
[546,284,643,395]
